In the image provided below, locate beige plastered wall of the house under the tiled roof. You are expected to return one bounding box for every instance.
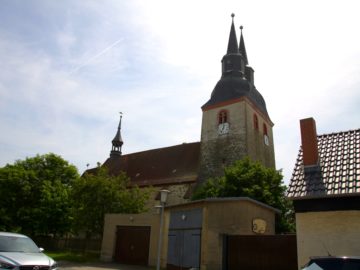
[296,211,360,269]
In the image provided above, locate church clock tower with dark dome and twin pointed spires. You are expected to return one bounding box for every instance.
[199,14,275,182]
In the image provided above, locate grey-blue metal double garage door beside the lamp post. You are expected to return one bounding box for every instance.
[167,209,202,270]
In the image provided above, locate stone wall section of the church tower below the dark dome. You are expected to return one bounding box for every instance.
[199,99,275,181]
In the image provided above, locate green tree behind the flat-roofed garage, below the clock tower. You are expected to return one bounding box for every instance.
[192,158,295,233]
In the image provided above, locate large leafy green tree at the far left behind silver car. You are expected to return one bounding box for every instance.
[0,153,79,235]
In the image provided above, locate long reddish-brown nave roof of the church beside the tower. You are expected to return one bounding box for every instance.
[103,142,200,186]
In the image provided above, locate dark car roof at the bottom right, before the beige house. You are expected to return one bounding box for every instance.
[302,256,360,270]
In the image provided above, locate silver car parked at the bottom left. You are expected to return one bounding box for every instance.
[0,232,57,270]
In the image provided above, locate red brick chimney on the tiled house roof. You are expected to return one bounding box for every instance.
[300,117,319,166]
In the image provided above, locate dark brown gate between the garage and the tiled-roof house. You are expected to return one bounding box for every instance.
[224,235,297,270]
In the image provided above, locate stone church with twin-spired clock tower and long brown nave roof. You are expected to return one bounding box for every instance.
[97,13,275,204]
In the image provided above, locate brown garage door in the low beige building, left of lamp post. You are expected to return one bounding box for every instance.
[115,226,150,265]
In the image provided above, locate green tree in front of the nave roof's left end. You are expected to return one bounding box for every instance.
[72,167,150,237]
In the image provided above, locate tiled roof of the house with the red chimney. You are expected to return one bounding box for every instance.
[287,129,360,199]
